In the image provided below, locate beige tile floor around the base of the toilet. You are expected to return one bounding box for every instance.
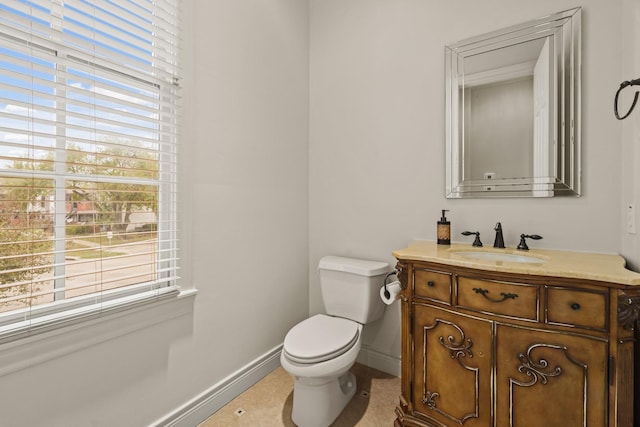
[199,363,400,427]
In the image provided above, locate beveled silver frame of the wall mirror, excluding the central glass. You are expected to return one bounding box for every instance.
[445,7,582,198]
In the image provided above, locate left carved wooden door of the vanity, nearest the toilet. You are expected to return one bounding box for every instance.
[412,305,493,427]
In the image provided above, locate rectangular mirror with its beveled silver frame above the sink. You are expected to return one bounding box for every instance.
[445,8,581,198]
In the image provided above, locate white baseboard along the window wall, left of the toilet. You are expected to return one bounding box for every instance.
[151,345,282,427]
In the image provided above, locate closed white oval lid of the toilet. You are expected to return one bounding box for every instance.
[284,314,359,363]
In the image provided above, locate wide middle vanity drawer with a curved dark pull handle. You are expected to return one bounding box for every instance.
[458,277,539,320]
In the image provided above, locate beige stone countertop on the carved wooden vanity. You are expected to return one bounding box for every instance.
[393,240,640,286]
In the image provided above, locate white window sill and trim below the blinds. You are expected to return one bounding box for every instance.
[0,289,197,377]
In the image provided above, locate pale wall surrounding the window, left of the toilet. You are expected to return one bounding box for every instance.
[0,0,309,427]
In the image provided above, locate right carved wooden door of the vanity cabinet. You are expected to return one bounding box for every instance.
[495,324,608,427]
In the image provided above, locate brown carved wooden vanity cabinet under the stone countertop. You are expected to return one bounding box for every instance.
[395,259,637,427]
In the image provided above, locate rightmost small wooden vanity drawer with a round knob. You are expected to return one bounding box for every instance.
[547,287,609,330]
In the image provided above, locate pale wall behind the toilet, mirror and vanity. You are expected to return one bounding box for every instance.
[309,0,640,364]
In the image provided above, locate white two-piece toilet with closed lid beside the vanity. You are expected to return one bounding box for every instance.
[280,256,389,427]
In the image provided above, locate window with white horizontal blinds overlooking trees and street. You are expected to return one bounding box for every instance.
[0,0,179,339]
